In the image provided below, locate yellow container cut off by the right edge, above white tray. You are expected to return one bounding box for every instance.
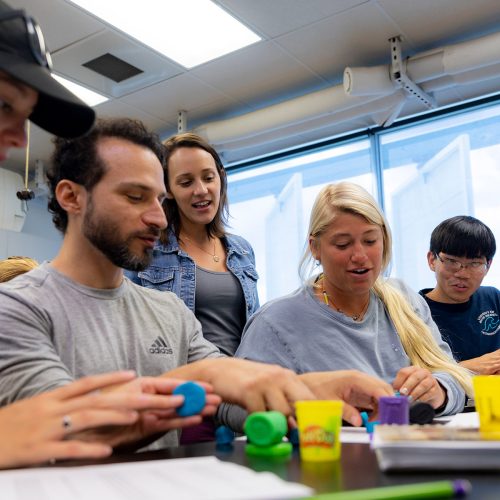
[472,375,500,437]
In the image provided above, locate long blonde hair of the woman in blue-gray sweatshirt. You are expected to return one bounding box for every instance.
[300,182,473,397]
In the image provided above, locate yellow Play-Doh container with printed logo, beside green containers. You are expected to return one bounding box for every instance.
[295,401,342,462]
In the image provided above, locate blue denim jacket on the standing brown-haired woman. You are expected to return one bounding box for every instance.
[125,227,259,320]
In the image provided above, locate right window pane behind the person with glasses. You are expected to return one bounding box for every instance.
[380,106,500,290]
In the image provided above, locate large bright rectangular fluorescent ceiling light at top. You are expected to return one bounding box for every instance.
[71,0,261,68]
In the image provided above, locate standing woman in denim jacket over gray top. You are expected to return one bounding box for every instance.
[127,133,259,356]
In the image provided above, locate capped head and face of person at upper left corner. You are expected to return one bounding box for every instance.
[0,0,95,147]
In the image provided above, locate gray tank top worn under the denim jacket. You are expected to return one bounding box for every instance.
[194,266,245,356]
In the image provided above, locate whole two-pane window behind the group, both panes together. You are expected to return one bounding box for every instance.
[228,99,500,304]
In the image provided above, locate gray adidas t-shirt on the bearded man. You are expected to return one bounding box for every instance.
[0,263,221,446]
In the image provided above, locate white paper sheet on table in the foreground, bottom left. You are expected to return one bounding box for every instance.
[0,457,314,500]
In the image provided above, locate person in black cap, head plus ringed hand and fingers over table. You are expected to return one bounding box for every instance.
[0,0,224,468]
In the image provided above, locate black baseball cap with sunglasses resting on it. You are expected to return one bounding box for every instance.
[0,0,95,139]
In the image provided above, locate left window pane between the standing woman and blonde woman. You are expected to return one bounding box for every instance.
[228,139,375,303]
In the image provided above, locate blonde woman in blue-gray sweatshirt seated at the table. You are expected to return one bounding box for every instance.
[236,182,472,414]
